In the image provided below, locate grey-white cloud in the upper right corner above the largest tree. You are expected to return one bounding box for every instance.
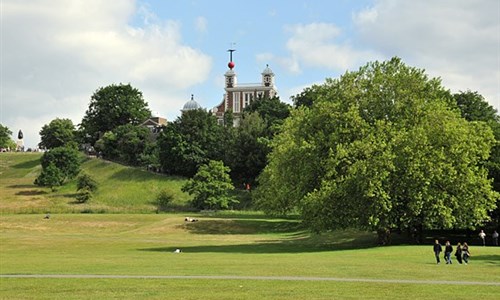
[353,0,500,109]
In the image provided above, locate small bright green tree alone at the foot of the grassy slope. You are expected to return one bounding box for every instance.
[182,160,238,209]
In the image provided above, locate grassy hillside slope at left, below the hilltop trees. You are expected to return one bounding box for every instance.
[0,153,189,213]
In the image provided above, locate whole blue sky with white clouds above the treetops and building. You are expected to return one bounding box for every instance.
[0,0,500,147]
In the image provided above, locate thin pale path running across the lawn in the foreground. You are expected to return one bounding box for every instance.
[0,274,500,286]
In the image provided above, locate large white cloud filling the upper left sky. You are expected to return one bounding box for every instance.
[0,0,212,147]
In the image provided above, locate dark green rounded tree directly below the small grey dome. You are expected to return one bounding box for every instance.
[157,109,224,177]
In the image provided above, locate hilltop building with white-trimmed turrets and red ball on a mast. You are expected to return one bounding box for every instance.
[212,50,278,126]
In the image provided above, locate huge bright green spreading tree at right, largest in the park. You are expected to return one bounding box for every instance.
[257,58,498,243]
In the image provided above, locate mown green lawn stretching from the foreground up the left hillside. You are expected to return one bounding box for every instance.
[0,154,500,299]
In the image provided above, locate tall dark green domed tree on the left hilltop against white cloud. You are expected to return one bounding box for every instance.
[80,84,151,144]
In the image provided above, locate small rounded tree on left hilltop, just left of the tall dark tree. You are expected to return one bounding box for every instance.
[38,118,76,149]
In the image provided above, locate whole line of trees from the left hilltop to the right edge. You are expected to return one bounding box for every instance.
[5,58,500,239]
